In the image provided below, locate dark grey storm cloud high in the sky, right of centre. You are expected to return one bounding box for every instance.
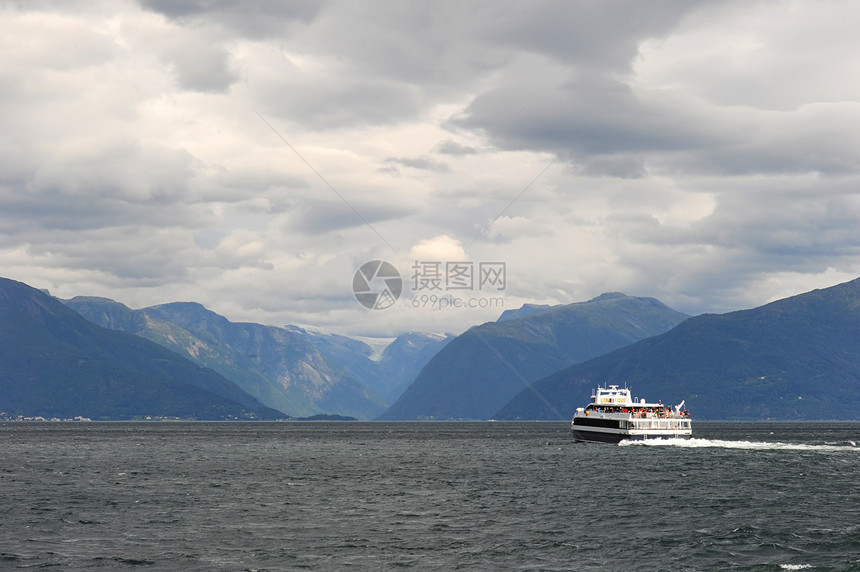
[448,67,716,155]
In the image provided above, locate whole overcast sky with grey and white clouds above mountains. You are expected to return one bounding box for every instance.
[0,0,860,336]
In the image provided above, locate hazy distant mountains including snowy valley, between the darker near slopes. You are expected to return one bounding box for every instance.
[65,297,450,419]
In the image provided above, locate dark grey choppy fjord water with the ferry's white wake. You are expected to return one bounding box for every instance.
[0,423,860,570]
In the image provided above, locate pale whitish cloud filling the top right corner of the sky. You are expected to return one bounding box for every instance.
[634,2,860,111]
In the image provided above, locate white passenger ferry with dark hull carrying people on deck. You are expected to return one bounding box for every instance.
[570,385,693,443]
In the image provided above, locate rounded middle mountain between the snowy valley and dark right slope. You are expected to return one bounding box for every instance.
[380,293,687,419]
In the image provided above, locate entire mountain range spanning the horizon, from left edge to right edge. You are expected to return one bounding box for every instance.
[0,278,860,420]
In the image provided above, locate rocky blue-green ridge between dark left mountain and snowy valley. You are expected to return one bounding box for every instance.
[65,297,385,419]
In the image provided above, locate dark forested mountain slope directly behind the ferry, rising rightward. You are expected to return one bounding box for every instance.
[497,279,860,420]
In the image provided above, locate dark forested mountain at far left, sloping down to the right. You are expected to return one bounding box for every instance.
[0,278,283,419]
